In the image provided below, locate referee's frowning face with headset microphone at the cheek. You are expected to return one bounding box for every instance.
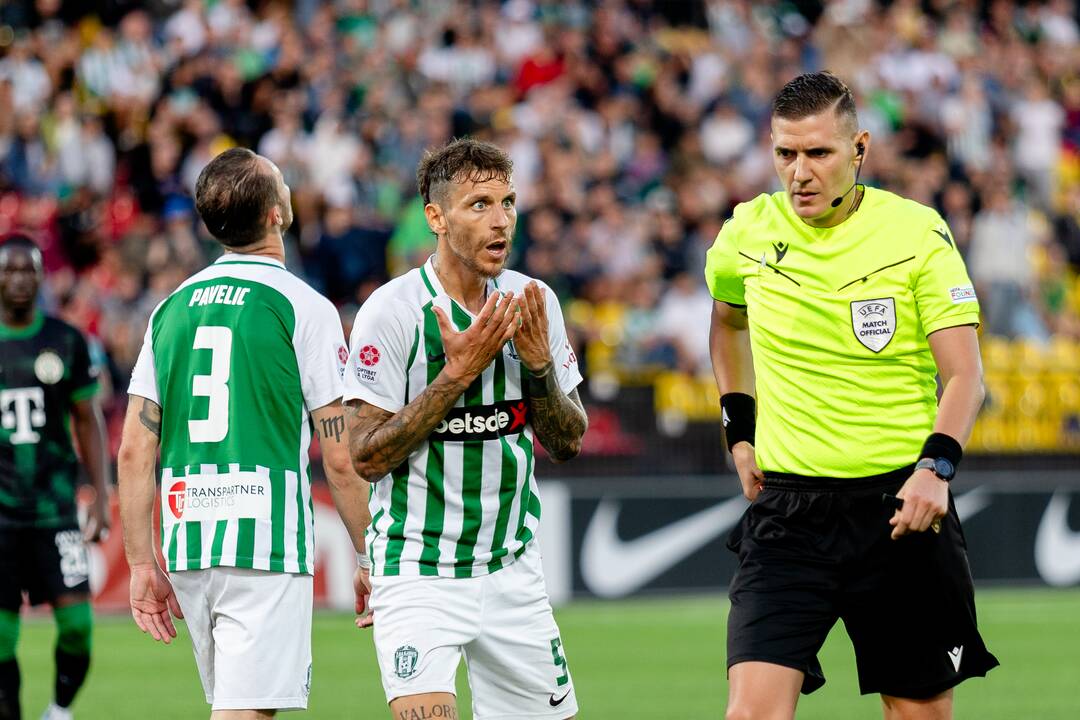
[772,108,869,228]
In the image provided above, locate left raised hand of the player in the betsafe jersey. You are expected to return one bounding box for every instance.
[432,293,517,384]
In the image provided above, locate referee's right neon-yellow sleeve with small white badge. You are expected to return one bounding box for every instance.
[915,217,978,335]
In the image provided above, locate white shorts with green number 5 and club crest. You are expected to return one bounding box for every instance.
[370,543,578,720]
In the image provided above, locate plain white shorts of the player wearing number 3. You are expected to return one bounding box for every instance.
[170,568,313,710]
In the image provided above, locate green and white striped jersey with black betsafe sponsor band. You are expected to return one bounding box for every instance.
[345,259,581,578]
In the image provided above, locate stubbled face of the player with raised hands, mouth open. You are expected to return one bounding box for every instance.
[428,178,517,277]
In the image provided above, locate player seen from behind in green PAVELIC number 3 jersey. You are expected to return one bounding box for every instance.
[119,148,369,718]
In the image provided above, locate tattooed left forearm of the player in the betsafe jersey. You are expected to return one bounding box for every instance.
[346,375,465,483]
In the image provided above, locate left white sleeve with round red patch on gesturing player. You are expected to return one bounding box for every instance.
[345,293,417,412]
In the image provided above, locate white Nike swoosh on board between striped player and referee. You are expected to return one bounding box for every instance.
[581,495,746,598]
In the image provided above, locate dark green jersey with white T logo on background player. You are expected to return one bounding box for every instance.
[0,313,97,528]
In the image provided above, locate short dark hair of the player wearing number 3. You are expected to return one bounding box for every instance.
[195,148,281,247]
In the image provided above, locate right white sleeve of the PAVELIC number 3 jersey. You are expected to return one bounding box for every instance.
[296,297,348,412]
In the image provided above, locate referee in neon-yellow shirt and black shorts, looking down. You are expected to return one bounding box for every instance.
[705,72,998,720]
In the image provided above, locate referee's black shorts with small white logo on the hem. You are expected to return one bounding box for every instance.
[728,467,998,698]
